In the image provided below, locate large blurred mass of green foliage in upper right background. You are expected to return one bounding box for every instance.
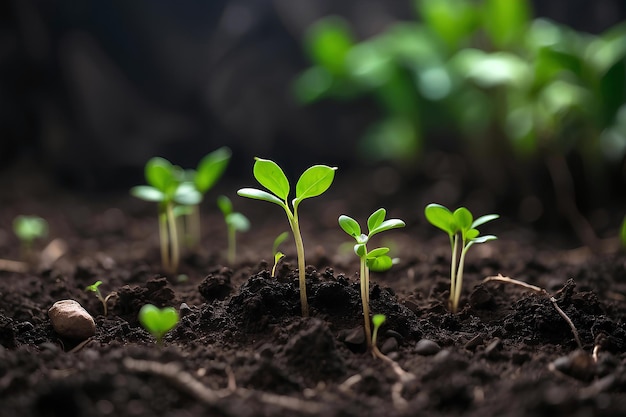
[294,0,626,166]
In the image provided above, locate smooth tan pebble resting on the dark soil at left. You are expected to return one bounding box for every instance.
[48,300,96,340]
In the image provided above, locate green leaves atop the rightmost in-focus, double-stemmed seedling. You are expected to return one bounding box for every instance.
[424,203,500,245]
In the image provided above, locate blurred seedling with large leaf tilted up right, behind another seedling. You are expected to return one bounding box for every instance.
[183,146,232,248]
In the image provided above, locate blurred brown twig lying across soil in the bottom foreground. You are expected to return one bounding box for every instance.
[123,358,322,414]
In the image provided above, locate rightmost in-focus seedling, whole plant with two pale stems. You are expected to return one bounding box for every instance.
[424,204,500,313]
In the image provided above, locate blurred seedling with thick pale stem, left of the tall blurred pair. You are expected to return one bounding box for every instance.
[130,157,202,273]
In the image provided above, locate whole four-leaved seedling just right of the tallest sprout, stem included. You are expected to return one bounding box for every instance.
[339,208,406,349]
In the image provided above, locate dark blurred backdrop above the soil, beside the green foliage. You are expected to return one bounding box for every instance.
[0,0,626,190]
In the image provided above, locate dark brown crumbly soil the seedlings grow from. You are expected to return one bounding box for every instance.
[0,167,626,417]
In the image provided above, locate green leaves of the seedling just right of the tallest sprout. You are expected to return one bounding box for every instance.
[339,208,405,272]
